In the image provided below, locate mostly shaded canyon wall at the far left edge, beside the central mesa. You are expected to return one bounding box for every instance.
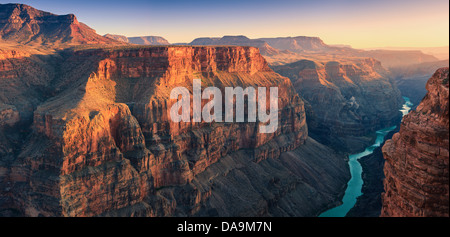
[0,44,58,216]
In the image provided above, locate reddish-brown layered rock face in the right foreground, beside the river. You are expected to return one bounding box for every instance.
[381,67,449,217]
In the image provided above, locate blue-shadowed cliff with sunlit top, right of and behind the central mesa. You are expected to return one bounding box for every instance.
[273,59,402,151]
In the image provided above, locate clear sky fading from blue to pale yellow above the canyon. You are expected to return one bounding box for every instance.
[0,0,449,48]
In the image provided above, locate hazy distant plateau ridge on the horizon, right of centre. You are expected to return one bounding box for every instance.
[188,35,439,68]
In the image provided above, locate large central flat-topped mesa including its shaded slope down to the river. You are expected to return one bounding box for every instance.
[0,46,349,216]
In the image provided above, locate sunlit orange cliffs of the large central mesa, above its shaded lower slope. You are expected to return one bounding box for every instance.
[13,46,307,216]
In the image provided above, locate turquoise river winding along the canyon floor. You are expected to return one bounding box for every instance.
[319,96,413,217]
